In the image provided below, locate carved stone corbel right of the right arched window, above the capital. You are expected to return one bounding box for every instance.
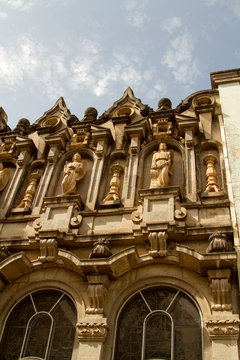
[208,269,232,311]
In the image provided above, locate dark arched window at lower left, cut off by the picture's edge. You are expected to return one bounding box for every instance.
[0,290,77,360]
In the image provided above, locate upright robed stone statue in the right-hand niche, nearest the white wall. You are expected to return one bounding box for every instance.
[150,143,173,189]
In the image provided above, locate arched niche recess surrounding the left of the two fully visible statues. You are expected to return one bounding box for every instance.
[47,149,95,203]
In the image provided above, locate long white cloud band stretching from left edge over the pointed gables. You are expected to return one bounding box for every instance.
[0,31,159,105]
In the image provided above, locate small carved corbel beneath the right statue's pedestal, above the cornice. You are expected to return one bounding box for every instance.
[148,231,168,258]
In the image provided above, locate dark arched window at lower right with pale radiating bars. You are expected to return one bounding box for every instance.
[114,287,202,360]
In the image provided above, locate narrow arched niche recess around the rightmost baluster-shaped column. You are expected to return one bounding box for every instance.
[198,141,224,193]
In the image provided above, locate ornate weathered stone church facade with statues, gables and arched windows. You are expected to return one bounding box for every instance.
[0,69,240,360]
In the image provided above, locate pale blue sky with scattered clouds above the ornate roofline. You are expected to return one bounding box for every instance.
[0,0,240,129]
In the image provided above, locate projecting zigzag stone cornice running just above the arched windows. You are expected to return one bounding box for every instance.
[0,245,237,289]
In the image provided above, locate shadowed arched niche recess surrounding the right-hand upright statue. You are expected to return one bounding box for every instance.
[137,139,185,197]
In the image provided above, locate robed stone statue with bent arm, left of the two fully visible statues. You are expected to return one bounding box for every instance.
[62,153,87,195]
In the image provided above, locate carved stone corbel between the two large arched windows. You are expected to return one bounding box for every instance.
[86,275,109,314]
